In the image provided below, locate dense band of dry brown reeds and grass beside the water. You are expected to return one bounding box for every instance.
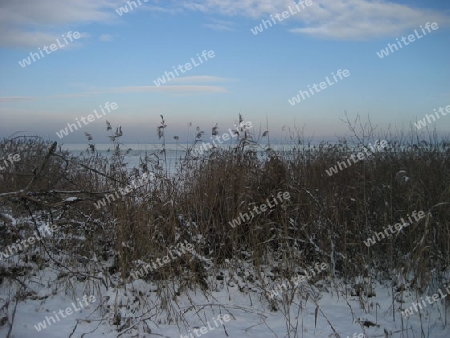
[0,116,450,332]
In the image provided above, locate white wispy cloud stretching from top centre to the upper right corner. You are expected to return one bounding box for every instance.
[180,0,450,40]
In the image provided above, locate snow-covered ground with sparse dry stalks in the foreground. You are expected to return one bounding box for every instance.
[0,263,450,338]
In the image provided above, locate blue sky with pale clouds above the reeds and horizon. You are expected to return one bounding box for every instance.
[0,0,450,144]
